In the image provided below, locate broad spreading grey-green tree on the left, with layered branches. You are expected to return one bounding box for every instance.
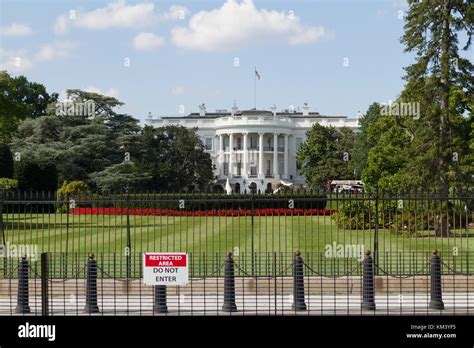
[12,90,140,188]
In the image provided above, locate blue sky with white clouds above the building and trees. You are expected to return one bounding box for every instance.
[0,0,413,120]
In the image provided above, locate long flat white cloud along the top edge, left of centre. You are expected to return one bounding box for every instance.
[54,0,189,34]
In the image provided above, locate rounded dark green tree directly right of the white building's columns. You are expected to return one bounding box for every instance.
[296,124,355,189]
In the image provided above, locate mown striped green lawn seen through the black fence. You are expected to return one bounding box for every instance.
[3,214,474,274]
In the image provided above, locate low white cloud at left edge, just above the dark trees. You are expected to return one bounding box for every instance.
[0,41,77,71]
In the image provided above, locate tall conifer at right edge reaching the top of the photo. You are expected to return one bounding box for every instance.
[401,0,474,191]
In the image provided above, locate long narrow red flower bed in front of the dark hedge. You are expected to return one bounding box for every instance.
[71,208,336,216]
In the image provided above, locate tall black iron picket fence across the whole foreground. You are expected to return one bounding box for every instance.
[0,191,474,315]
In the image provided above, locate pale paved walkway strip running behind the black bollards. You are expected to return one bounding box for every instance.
[0,293,474,316]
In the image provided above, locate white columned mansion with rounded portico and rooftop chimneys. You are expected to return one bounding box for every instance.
[146,103,359,192]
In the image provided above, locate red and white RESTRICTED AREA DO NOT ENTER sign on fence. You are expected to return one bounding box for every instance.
[143,253,189,285]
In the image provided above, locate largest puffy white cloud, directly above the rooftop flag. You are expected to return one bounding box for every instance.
[171,0,326,51]
